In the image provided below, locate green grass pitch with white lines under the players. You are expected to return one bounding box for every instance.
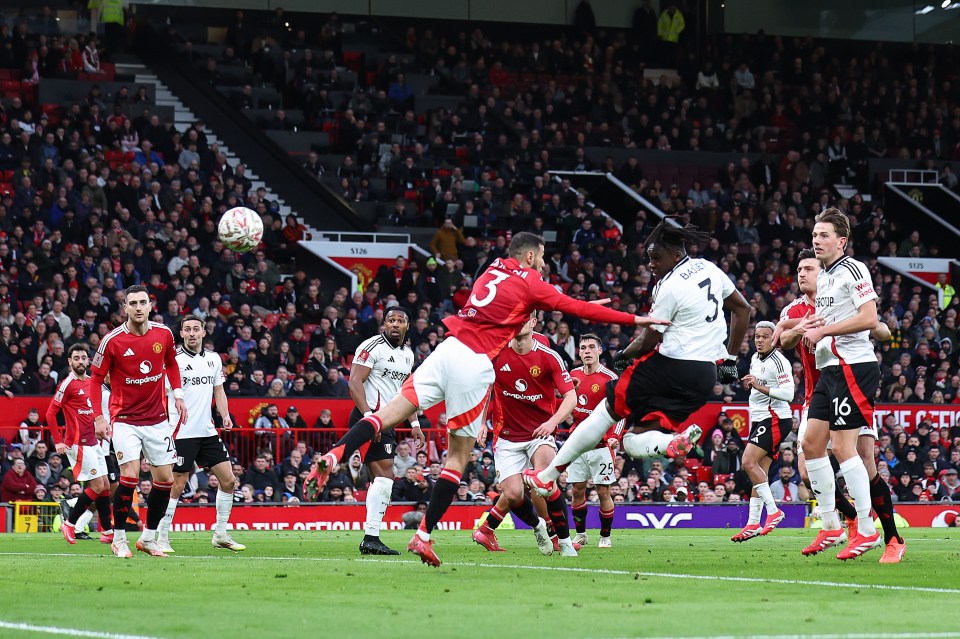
[0,529,960,639]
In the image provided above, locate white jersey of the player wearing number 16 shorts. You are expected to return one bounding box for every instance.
[816,255,877,369]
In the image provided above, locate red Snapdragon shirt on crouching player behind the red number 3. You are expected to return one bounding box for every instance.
[491,340,573,442]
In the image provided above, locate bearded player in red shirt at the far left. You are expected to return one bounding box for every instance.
[47,344,113,544]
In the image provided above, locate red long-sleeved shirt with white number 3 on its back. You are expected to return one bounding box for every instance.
[443,258,634,360]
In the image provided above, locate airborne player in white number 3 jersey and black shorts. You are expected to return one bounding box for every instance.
[524,220,750,495]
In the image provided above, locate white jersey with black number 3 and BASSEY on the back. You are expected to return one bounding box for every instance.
[650,257,735,362]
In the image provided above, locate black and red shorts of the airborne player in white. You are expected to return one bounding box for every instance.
[607,351,717,432]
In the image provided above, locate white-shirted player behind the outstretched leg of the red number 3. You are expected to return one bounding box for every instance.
[350,306,424,555]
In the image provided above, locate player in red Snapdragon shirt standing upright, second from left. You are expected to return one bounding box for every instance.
[90,285,187,558]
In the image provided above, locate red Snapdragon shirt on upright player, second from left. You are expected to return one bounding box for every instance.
[90,322,181,426]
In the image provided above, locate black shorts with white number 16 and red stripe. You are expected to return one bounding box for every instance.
[807,362,880,430]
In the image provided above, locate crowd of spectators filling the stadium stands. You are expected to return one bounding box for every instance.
[0,7,960,503]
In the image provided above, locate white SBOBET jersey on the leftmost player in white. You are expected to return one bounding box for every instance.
[167,346,224,439]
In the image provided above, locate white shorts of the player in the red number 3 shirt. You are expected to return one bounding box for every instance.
[400,337,495,438]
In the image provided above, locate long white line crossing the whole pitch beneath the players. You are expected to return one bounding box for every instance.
[0,552,960,596]
